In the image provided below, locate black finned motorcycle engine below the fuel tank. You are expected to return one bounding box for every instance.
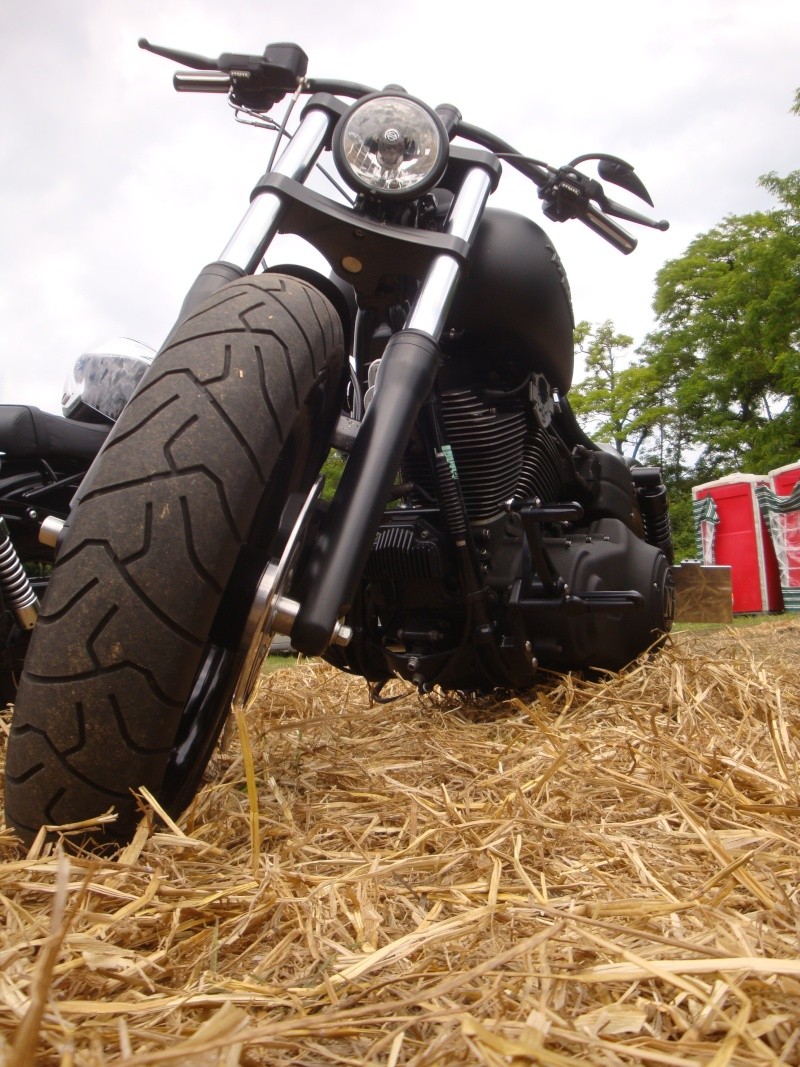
[332,375,671,690]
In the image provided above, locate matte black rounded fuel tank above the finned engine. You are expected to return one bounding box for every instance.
[448,208,575,393]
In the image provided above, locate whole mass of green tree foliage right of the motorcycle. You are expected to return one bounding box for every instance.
[571,89,800,558]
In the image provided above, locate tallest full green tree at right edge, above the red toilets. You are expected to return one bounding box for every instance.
[644,158,800,476]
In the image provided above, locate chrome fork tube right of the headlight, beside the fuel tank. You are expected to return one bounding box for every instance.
[405,168,492,340]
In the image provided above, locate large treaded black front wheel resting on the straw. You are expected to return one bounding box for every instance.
[5,274,346,843]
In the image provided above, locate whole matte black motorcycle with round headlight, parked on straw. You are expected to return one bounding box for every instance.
[5,39,674,846]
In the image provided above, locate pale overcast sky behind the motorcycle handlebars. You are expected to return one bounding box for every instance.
[0,0,800,412]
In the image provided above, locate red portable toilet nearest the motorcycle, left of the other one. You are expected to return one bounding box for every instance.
[691,474,783,615]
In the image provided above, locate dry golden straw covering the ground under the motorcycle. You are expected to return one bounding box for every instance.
[0,617,800,1067]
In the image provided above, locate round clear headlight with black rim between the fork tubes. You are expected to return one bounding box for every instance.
[333,93,448,200]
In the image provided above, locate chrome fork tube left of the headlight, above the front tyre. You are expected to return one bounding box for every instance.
[220,110,331,274]
